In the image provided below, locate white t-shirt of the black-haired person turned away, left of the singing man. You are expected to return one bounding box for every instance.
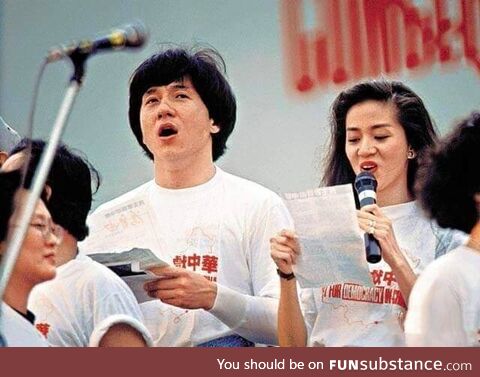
[28,255,151,347]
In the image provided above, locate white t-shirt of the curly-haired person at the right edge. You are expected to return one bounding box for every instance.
[405,246,480,347]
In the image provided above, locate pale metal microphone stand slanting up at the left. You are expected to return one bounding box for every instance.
[0,52,88,347]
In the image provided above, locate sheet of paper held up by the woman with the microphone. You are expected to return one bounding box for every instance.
[284,185,373,288]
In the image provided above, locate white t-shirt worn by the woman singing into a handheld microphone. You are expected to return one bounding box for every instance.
[300,202,466,346]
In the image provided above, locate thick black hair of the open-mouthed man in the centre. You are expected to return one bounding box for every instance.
[128,48,237,161]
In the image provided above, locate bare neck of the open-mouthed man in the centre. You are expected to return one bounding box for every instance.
[154,153,215,189]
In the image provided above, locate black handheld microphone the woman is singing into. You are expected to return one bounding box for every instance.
[355,171,382,263]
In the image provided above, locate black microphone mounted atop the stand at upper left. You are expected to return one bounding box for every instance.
[46,22,148,63]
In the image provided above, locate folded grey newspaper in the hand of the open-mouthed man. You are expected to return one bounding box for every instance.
[89,247,169,303]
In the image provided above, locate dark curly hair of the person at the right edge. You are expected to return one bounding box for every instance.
[417,112,480,233]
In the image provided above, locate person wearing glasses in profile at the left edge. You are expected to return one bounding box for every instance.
[0,170,62,347]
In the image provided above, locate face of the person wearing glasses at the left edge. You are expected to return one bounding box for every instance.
[2,192,59,287]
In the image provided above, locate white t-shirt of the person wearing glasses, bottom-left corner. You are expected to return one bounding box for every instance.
[0,301,48,347]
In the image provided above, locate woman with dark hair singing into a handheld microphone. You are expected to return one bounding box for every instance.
[271,80,464,346]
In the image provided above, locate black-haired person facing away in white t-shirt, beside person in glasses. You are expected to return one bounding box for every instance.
[3,139,150,347]
